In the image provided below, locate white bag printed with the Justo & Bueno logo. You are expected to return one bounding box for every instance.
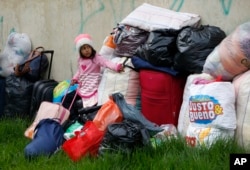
[189,82,236,130]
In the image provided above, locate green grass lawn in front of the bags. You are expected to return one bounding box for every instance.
[0,118,247,170]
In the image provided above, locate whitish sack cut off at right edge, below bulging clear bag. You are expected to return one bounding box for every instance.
[233,71,250,148]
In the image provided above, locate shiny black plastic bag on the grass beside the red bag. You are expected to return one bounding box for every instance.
[99,119,150,154]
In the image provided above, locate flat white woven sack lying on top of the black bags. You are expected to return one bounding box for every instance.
[121,3,201,31]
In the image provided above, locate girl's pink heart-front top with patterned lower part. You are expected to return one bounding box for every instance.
[73,54,121,98]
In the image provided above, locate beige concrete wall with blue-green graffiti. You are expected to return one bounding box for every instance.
[0,0,250,81]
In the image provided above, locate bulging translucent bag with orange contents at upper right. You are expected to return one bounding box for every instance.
[203,22,250,80]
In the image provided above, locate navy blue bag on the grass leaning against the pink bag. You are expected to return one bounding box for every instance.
[24,119,64,159]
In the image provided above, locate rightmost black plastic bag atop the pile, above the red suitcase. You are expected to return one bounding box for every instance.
[174,25,226,74]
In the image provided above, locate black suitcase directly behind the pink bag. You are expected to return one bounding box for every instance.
[29,79,59,117]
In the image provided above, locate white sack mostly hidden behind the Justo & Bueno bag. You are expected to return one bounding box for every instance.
[177,73,213,137]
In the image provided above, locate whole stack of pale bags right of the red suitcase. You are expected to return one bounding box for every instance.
[178,22,250,148]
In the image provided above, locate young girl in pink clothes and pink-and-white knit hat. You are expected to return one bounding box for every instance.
[71,34,123,108]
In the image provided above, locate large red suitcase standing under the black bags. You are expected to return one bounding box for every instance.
[139,69,186,126]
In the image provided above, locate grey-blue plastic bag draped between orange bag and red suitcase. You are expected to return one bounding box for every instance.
[112,92,163,134]
